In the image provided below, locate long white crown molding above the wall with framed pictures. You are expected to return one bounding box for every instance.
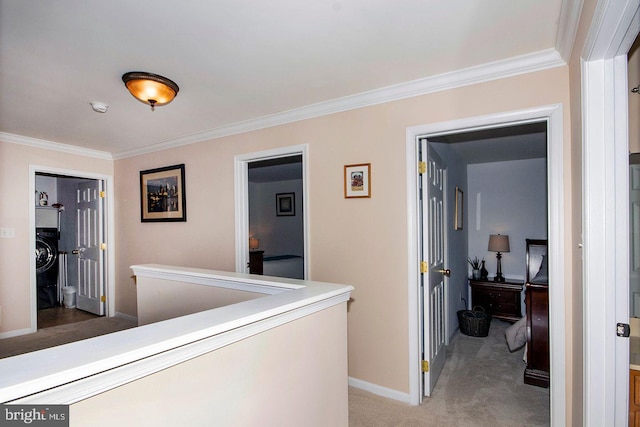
[113,49,566,160]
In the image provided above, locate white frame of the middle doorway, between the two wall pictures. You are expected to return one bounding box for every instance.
[234,144,311,280]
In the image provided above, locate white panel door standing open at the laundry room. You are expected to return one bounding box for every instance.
[73,180,105,316]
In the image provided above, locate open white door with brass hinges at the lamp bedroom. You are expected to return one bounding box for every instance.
[418,139,449,396]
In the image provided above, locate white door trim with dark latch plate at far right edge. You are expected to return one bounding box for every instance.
[581,0,640,426]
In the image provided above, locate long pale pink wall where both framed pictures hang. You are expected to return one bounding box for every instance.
[115,67,579,400]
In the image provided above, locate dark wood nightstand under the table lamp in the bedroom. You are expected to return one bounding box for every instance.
[469,280,524,322]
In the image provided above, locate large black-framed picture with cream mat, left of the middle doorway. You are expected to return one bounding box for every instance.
[140,164,187,222]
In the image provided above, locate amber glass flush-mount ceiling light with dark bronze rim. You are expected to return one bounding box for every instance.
[122,71,180,111]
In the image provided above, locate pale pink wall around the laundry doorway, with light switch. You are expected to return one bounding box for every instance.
[0,141,113,333]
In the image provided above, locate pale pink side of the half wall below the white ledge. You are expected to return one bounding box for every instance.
[69,303,349,427]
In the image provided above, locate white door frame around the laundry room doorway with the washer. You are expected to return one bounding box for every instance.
[29,165,116,332]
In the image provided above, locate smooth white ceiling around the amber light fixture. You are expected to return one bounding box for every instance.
[0,0,570,158]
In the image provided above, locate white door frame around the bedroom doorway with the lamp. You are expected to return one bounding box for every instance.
[406,104,566,425]
